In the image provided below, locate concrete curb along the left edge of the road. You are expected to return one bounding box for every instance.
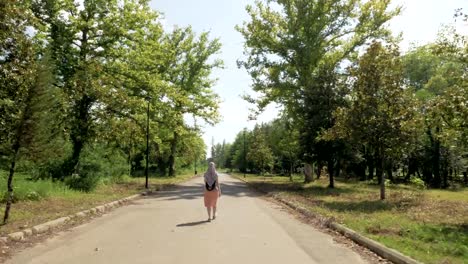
[0,192,147,243]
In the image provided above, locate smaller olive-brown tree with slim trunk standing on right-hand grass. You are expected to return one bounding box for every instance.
[326,42,417,200]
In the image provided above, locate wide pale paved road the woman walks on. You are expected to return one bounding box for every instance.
[7,175,364,264]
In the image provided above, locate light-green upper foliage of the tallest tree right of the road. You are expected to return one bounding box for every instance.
[237,0,399,114]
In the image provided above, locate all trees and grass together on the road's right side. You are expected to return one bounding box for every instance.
[212,3,468,263]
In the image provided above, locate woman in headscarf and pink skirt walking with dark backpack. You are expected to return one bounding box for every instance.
[204,162,221,222]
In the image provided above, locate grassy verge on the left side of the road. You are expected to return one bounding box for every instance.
[0,173,193,236]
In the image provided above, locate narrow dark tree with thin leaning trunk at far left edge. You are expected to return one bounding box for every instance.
[0,1,40,224]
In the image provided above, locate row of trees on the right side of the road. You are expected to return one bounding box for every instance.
[218,0,468,198]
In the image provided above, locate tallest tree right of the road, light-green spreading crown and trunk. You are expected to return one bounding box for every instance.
[237,0,400,187]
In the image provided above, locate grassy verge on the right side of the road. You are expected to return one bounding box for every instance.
[234,174,468,264]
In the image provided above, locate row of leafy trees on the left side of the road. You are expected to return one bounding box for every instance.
[0,0,222,222]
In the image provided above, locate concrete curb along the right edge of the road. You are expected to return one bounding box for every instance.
[235,177,422,264]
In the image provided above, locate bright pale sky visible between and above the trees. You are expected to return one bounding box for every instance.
[151,0,468,153]
